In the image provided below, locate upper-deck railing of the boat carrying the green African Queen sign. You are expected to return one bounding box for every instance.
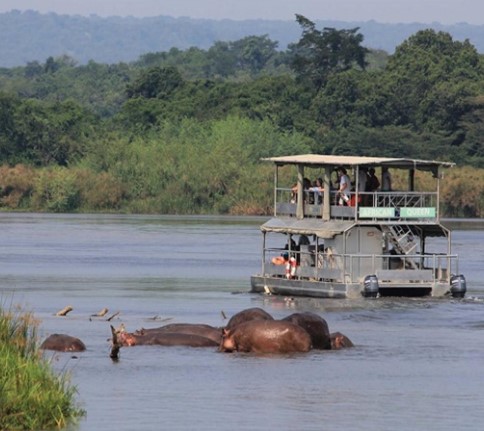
[274,188,438,221]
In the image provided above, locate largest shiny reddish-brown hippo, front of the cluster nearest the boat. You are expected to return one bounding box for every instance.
[219,320,311,353]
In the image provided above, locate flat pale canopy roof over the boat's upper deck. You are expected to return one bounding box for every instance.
[262,154,455,173]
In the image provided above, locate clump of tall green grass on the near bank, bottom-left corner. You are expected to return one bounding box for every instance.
[0,307,83,430]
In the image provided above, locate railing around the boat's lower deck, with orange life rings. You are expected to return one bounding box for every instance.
[263,248,459,285]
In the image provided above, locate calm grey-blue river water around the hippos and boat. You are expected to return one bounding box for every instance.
[0,214,484,431]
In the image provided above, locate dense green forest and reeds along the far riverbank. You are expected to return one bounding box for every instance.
[0,15,484,217]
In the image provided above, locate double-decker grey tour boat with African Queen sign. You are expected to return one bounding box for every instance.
[251,154,466,298]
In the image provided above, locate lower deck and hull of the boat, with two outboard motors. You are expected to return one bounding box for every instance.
[251,218,465,298]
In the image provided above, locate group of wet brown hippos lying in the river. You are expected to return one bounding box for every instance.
[40,307,353,360]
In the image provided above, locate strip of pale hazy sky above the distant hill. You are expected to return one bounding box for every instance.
[0,0,484,24]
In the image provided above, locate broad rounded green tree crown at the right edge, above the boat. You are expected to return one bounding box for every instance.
[384,29,483,133]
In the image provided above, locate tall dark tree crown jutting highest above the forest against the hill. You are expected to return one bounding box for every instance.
[289,15,368,89]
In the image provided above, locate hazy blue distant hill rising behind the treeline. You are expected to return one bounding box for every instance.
[0,11,484,67]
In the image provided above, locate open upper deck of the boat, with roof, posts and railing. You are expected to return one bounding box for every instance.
[264,154,454,224]
